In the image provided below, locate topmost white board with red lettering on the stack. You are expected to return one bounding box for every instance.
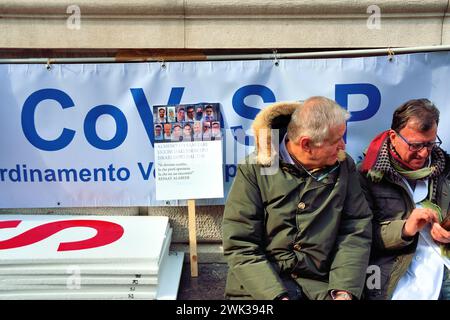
[0,215,171,269]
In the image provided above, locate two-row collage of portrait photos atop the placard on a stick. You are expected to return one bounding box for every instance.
[153,103,222,143]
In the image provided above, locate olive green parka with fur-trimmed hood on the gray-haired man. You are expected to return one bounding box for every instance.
[223,103,372,299]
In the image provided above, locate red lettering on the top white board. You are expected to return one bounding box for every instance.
[0,220,124,251]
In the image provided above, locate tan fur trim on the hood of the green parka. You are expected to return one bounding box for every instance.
[252,101,301,166]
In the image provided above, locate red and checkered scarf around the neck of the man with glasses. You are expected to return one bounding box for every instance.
[361,131,445,202]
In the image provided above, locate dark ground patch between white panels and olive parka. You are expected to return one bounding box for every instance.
[177,263,228,300]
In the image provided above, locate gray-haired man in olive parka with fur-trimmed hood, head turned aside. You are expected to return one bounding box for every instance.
[223,97,372,300]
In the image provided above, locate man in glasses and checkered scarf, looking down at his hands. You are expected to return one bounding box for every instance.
[360,99,450,300]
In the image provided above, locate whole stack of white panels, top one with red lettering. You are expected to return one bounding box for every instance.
[0,215,183,299]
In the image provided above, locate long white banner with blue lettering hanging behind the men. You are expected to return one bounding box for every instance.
[0,52,450,208]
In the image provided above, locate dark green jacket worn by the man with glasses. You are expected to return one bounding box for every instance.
[358,149,450,300]
